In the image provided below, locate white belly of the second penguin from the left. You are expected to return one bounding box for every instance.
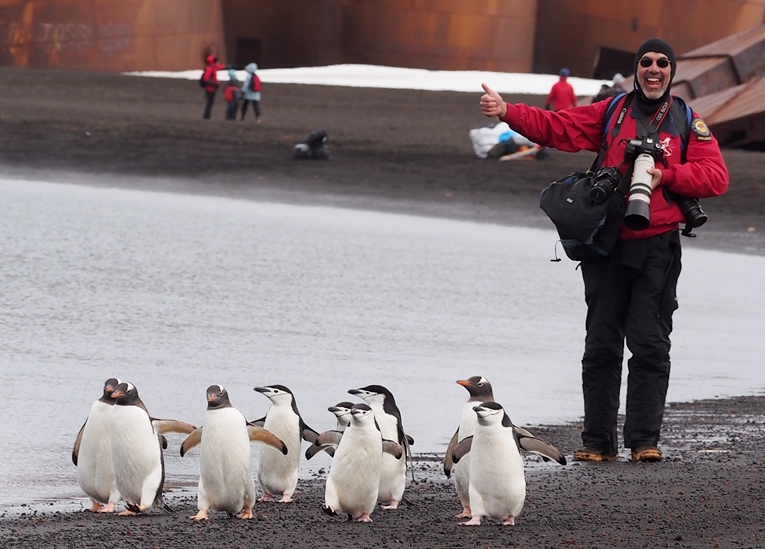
[112,405,163,510]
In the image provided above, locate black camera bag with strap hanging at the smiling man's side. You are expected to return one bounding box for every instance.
[539,94,632,261]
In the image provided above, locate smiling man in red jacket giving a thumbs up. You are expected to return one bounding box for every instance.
[480,39,728,461]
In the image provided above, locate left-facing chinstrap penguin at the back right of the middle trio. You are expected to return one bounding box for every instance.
[348,385,414,509]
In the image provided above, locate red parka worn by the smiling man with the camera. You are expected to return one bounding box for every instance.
[501,99,728,239]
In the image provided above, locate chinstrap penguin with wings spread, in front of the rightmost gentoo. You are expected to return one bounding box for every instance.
[452,402,566,526]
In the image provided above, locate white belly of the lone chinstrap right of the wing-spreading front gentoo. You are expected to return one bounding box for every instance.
[258,406,302,498]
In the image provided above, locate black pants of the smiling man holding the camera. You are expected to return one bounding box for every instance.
[581,231,681,454]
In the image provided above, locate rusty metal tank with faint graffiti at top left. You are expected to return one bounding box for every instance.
[0,0,225,72]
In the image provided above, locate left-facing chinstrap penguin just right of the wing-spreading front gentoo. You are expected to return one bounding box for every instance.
[253,385,319,503]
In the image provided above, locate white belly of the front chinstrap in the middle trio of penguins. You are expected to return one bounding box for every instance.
[324,428,383,519]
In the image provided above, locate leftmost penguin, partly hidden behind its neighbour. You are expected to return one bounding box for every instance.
[72,377,120,513]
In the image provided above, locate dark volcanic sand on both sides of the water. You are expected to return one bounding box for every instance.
[0,68,765,547]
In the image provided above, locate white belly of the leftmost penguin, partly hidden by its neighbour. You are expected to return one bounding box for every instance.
[77,400,120,504]
